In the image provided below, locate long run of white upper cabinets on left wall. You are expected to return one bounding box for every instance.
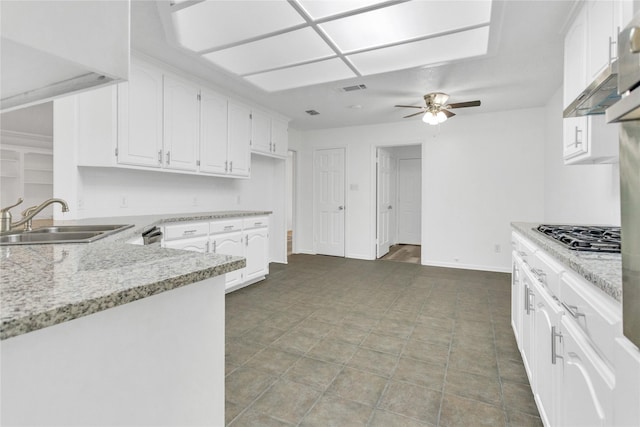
[71,61,272,178]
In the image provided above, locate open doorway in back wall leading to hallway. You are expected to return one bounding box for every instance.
[376,145,422,263]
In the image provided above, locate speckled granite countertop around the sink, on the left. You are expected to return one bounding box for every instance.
[0,211,271,340]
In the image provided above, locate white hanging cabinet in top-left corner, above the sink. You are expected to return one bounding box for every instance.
[0,0,130,112]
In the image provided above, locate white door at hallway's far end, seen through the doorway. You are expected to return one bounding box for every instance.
[398,159,422,245]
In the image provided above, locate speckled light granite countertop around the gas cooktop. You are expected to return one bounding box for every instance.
[511,222,622,302]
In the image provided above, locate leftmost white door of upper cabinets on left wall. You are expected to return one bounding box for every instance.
[118,62,162,167]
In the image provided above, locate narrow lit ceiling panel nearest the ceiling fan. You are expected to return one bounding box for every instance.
[347,26,489,75]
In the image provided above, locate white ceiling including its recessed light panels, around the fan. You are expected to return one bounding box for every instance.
[131,0,575,130]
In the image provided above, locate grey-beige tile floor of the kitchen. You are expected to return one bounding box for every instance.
[226,255,542,427]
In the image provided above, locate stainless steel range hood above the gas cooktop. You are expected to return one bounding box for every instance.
[563,61,620,119]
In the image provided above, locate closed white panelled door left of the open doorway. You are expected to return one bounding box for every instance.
[313,148,345,256]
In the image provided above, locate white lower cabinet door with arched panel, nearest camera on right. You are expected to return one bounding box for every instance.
[557,316,614,427]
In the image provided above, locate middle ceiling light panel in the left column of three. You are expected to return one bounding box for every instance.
[203,28,335,75]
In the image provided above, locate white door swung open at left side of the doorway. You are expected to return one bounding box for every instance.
[376,148,393,258]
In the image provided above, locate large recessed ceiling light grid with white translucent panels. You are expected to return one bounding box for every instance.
[165,0,491,92]
